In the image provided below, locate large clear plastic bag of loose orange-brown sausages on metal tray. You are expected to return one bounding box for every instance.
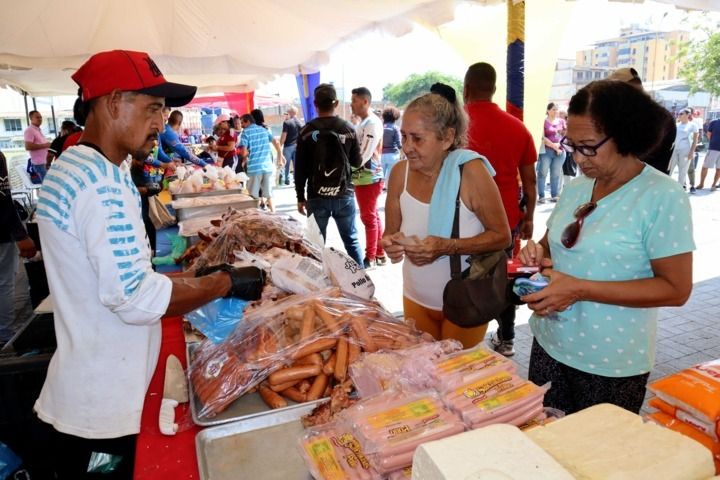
[190,289,428,417]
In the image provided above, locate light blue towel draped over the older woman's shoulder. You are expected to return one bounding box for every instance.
[428,149,495,238]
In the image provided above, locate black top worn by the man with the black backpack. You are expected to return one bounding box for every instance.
[295,116,362,202]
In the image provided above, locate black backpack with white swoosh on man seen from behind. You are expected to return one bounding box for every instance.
[302,124,352,197]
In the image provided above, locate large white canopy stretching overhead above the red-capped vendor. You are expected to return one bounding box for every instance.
[0,0,472,96]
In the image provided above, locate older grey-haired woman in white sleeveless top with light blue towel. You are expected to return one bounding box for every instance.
[382,84,510,347]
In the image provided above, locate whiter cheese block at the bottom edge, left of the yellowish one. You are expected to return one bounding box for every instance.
[412,424,573,480]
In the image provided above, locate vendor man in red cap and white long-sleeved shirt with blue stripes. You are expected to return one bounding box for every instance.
[35,50,262,479]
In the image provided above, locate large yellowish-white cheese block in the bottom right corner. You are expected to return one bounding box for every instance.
[525,404,715,480]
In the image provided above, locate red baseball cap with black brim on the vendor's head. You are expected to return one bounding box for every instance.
[72,50,197,107]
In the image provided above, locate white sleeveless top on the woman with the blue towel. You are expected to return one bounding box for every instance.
[400,162,485,310]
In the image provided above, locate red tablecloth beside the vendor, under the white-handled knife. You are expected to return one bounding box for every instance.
[135,317,200,480]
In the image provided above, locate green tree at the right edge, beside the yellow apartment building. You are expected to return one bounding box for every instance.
[678,29,720,96]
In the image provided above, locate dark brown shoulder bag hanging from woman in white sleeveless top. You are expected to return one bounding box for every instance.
[443,165,510,328]
